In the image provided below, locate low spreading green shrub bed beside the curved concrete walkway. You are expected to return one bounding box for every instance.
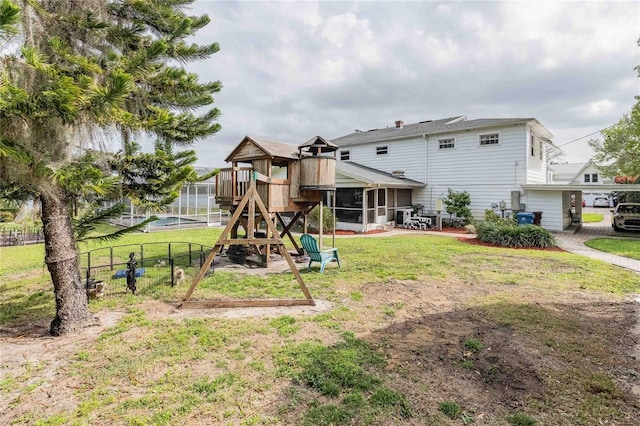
[476,222,556,248]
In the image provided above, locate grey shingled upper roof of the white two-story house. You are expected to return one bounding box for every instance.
[332,115,539,147]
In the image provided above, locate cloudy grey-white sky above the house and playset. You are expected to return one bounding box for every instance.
[182,0,640,167]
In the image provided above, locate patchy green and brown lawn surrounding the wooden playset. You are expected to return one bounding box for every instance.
[0,229,640,425]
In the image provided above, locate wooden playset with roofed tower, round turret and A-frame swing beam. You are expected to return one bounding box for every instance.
[180,136,338,307]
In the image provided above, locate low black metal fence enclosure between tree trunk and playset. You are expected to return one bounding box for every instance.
[80,242,213,297]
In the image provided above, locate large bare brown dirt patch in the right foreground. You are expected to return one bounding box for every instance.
[350,281,640,425]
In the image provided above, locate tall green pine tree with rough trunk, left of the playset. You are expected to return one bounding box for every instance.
[0,0,221,335]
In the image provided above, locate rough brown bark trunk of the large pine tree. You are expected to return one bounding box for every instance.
[40,190,95,336]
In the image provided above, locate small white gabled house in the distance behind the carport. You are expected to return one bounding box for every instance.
[549,160,613,207]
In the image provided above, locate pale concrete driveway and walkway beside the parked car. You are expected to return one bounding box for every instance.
[554,207,640,273]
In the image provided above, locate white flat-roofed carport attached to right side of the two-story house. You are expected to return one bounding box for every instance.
[522,183,640,231]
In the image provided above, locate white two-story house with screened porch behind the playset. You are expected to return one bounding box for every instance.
[332,116,552,231]
